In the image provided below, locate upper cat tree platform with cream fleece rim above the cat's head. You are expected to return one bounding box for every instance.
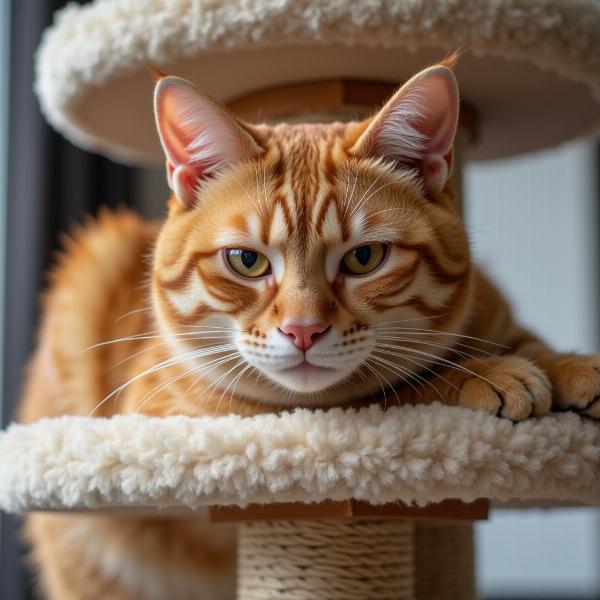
[36,0,600,165]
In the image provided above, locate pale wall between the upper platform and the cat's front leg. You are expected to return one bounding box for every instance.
[465,143,600,351]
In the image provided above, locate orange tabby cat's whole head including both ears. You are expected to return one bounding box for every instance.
[152,65,471,404]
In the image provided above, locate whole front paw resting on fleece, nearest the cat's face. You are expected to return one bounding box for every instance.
[458,356,552,421]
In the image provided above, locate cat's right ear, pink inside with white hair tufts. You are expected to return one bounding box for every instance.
[350,65,459,197]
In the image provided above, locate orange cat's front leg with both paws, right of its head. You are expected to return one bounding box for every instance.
[420,271,600,420]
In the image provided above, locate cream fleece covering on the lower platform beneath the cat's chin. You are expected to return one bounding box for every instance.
[0,404,600,512]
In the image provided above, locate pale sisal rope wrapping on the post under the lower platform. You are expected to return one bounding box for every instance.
[238,520,415,600]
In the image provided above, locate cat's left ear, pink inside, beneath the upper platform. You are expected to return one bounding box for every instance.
[154,76,263,207]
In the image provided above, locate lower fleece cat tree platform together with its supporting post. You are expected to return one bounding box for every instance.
[0,404,600,600]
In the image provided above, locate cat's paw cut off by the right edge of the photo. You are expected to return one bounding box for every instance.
[546,354,600,419]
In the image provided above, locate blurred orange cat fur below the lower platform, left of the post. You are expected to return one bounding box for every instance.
[26,513,235,600]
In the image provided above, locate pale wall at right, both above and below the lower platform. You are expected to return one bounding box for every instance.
[465,143,600,599]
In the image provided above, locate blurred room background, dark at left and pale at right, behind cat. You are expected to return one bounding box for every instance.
[0,0,600,600]
